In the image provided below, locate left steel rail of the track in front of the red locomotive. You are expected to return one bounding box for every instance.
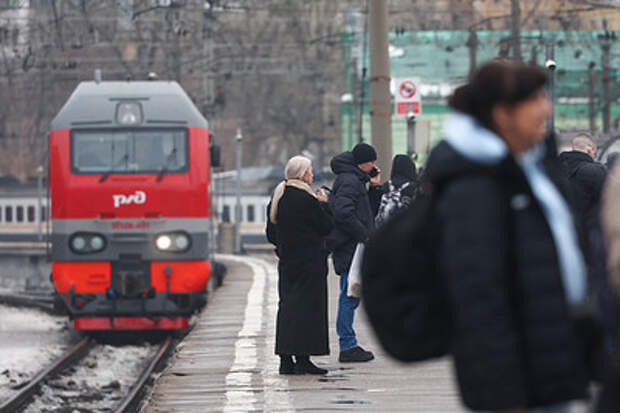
[0,337,94,413]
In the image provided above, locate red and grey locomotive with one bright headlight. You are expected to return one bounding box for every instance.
[49,81,211,330]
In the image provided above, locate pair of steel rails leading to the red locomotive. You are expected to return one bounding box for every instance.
[0,337,173,413]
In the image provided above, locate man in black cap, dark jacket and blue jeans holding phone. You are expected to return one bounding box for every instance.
[329,143,381,362]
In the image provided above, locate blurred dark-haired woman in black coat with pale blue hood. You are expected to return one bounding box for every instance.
[427,61,588,413]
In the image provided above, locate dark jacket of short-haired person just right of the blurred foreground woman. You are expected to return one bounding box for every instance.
[559,151,607,231]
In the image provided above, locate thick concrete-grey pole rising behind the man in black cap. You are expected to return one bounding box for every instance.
[368,0,392,176]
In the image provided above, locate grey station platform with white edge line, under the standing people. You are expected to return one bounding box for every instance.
[141,254,465,413]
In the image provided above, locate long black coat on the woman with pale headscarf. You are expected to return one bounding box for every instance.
[267,186,332,355]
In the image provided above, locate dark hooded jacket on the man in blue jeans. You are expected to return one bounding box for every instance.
[329,152,382,274]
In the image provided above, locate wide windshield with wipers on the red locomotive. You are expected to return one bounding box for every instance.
[71,129,188,174]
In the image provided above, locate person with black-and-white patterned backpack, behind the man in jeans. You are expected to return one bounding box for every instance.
[375,155,417,226]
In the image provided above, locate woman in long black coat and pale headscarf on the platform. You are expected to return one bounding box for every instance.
[267,156,332,374]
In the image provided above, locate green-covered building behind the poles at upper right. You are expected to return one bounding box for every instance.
[341,31,620,154]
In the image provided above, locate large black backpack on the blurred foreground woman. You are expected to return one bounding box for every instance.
[362,191,451,361]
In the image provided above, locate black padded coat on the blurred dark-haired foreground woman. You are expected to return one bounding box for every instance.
[428,142,587,410]
